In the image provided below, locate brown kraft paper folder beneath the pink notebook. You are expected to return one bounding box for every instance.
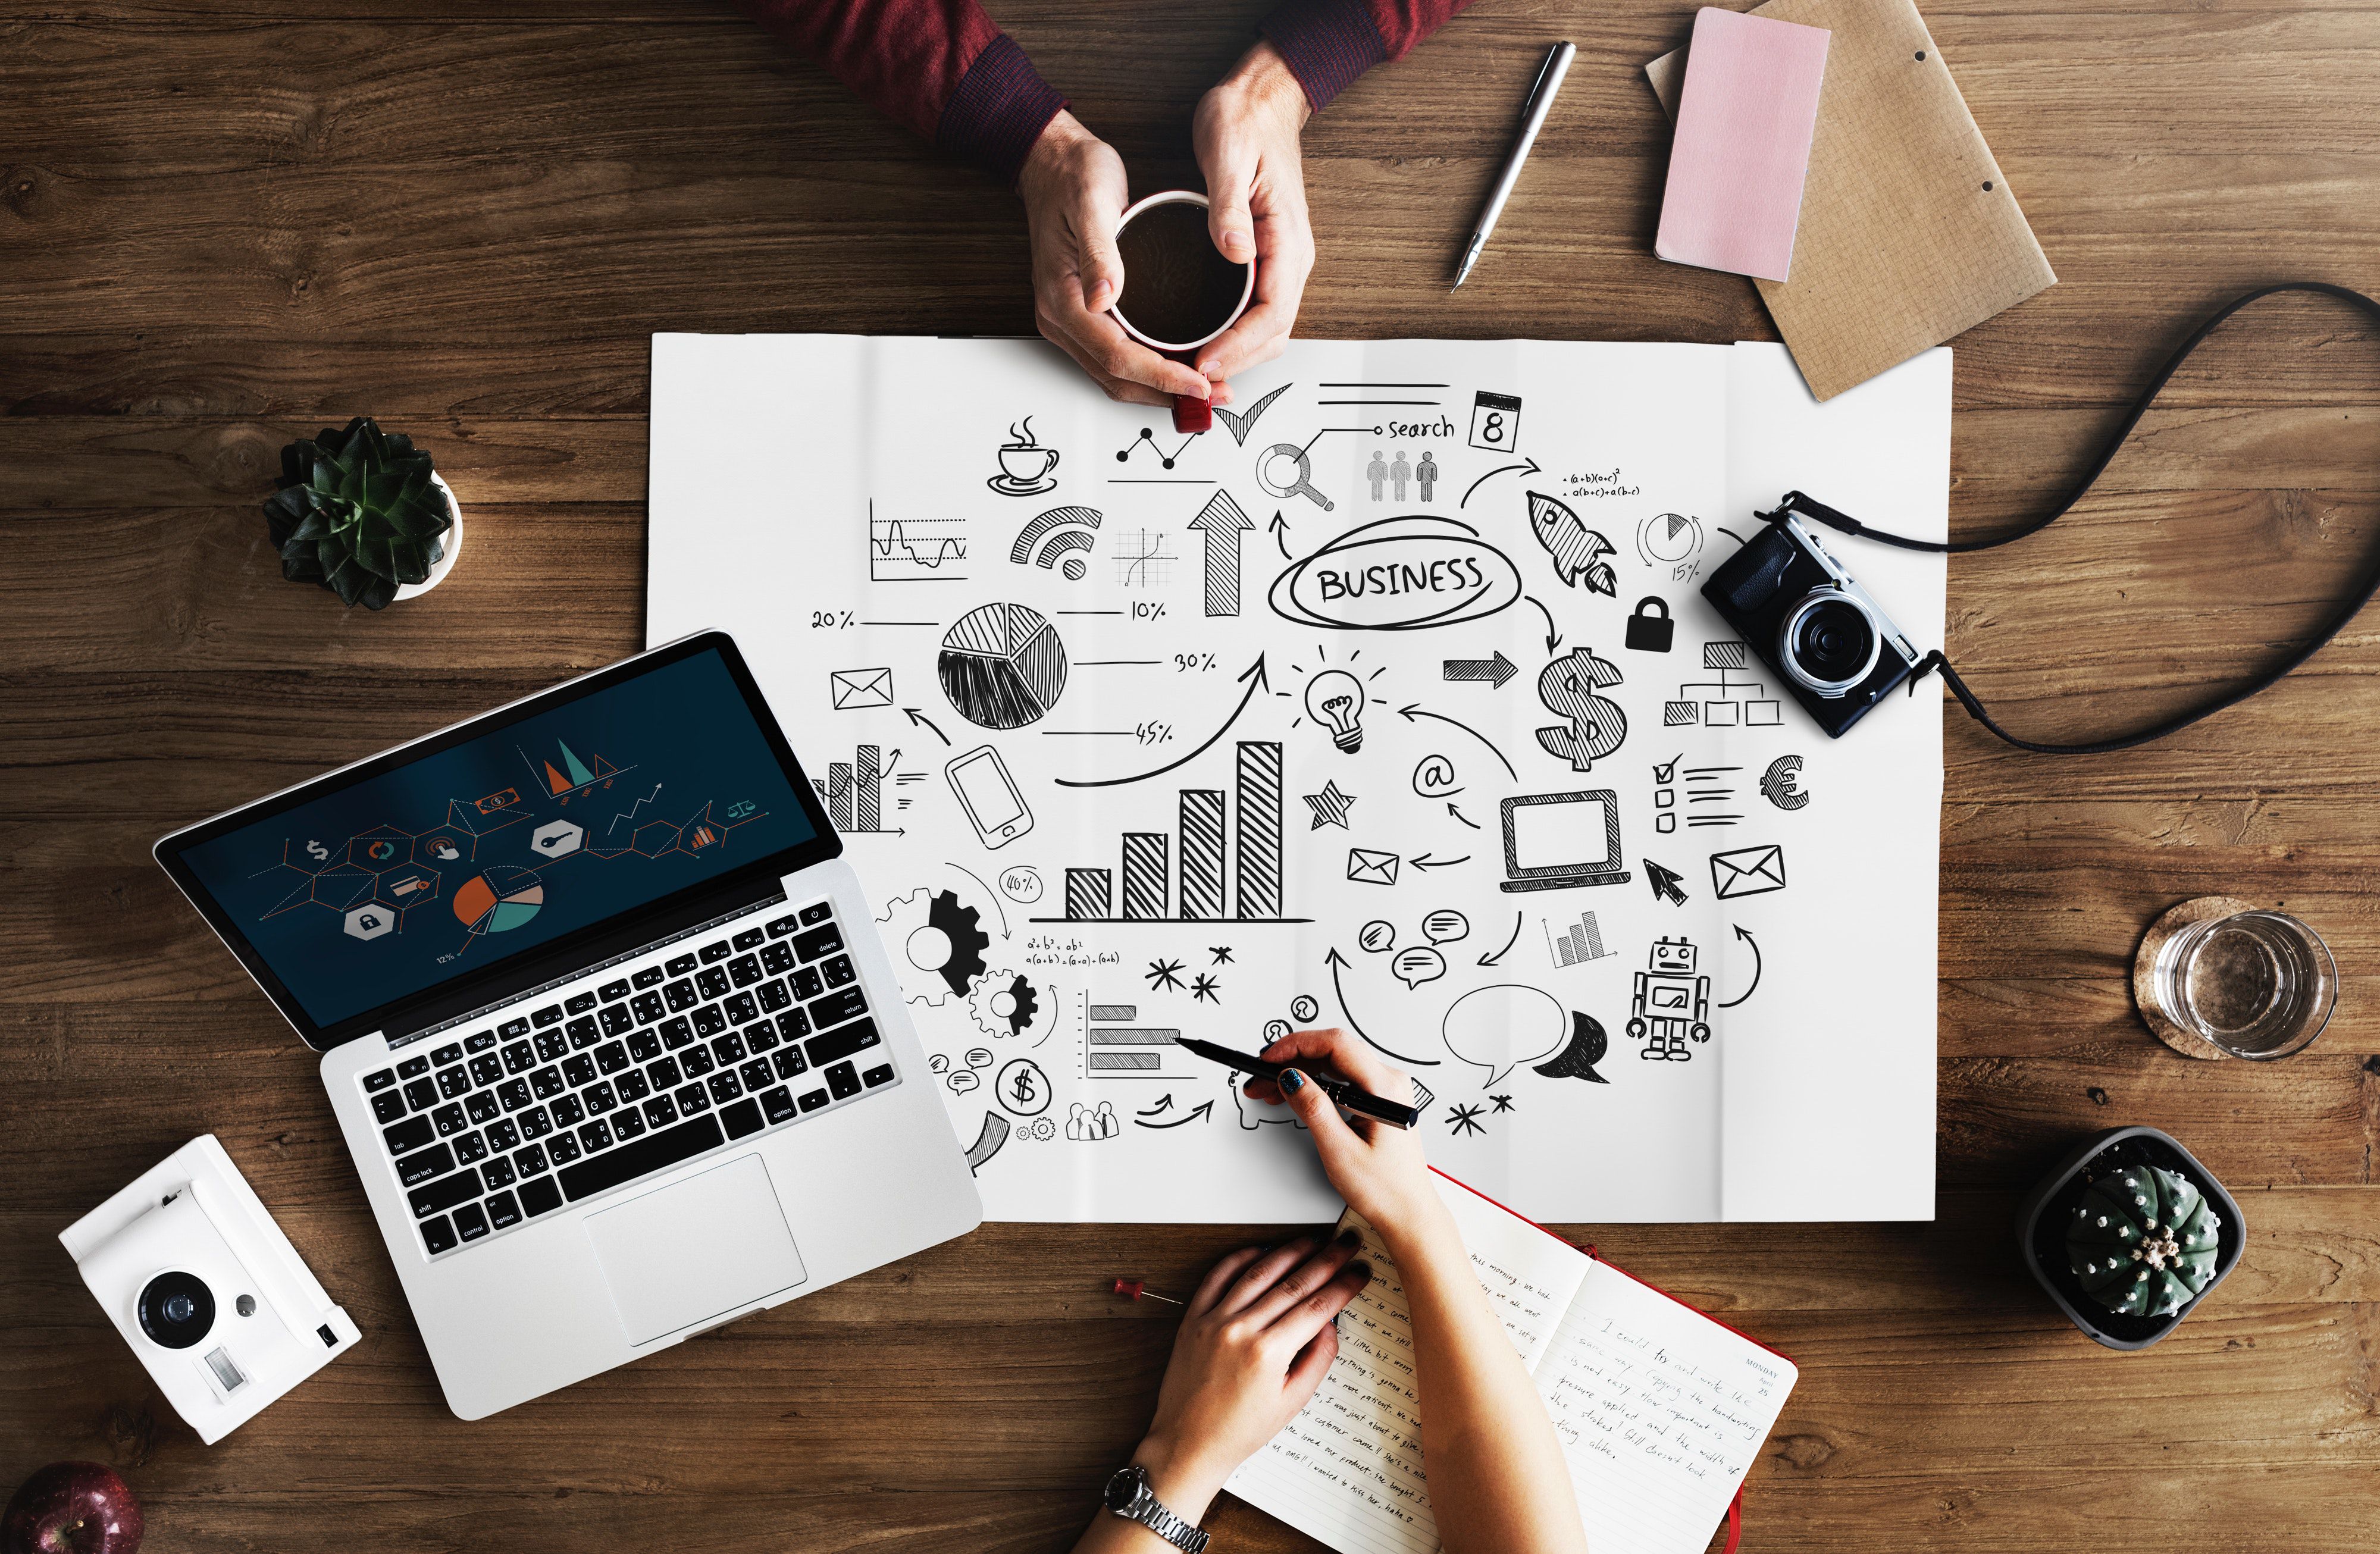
[1645,0,2056,400]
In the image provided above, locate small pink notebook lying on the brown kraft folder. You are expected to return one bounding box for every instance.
[1652,7,1828,281]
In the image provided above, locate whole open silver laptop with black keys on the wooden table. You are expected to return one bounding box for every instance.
[157,633,983,1418]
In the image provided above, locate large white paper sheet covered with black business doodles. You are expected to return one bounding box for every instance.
[647,336,1949,1221]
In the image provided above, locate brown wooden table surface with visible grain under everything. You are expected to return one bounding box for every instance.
[0,0,2380,1554]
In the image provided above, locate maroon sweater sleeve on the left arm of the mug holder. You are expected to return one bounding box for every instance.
[738,0,1066,183]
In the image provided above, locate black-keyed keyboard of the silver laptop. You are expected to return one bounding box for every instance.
[362,902,892,1257]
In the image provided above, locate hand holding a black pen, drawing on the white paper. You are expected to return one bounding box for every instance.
[1247,1030,1445,1245]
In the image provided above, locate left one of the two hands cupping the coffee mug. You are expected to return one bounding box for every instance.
[1016,109,1230,405]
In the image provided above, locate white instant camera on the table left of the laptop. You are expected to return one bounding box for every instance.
[57,1133,359,1447]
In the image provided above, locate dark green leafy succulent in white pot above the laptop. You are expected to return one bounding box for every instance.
[264,416,455,609]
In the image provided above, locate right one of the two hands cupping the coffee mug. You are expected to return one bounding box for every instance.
[1190,43,1314,383]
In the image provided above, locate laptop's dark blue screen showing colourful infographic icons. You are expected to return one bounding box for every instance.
[186,652,814,1026]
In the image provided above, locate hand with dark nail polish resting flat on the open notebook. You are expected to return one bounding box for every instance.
[1104,1233,1371,1547]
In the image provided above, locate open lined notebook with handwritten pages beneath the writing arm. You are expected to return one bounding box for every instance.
[1226,1173,1799,1554]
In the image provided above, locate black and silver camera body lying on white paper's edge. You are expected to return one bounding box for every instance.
[1702,512,1918,740]
